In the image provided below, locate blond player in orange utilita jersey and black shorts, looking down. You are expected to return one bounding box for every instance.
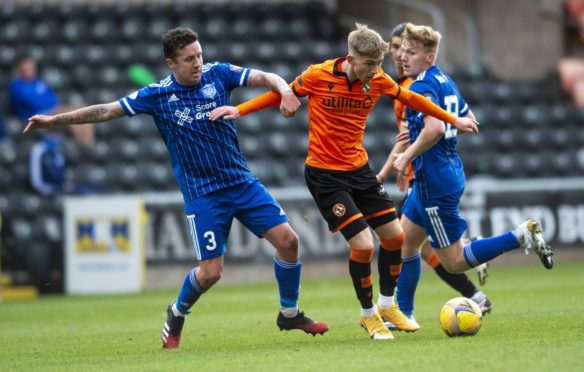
[210,24,478,340]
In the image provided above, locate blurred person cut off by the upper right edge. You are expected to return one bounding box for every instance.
[558,0,584,108]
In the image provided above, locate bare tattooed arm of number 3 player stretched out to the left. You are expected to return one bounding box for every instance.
[23,101,126,134]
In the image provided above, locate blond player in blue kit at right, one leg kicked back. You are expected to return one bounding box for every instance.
[394,23,553,324]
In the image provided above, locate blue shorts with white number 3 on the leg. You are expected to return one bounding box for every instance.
[185,178,288,261]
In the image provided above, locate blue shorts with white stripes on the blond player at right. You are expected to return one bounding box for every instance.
[402,187,468,248]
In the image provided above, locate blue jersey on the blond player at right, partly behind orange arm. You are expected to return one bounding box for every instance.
[406,66,470,199]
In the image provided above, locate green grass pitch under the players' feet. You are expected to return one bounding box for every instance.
[0,262,584,371]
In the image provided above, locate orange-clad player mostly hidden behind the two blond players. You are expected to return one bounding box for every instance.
[377,23,492,322]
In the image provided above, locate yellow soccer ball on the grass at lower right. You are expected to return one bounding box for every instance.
[440,297,483,337]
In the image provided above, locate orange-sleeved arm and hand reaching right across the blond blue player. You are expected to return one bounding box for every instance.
[396,88,479,133]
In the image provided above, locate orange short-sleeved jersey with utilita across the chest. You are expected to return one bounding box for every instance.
[293,58,399,171]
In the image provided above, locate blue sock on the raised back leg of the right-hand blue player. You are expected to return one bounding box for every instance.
[466,232,519,268]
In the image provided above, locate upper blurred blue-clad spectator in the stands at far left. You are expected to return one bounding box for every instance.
[9,56,95,147]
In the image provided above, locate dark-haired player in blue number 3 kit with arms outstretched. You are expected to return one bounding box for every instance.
[24,28,328,348]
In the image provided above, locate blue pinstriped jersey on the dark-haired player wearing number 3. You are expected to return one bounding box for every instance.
[119,62,253,200]
